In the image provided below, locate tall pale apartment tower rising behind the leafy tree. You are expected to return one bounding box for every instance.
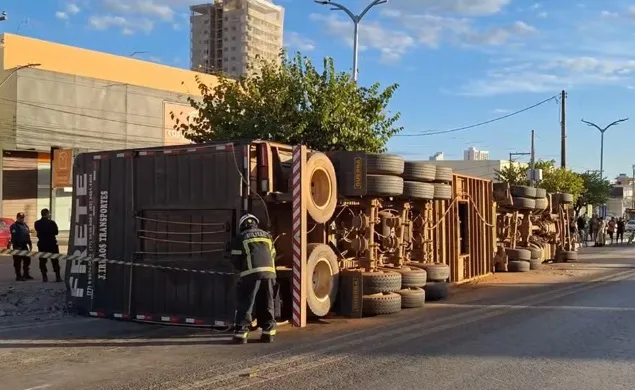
[190,0,284,77]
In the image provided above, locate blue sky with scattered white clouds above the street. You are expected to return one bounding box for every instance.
[0,0,635,178]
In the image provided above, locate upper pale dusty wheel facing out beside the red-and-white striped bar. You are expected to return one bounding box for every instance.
[306,153,337,223]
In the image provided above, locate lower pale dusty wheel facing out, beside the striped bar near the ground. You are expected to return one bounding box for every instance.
[306,244,340,317]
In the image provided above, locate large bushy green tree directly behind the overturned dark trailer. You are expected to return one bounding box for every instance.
[172,52,402,153]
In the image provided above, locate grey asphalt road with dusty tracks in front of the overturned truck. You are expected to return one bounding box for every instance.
[0,248,635,390]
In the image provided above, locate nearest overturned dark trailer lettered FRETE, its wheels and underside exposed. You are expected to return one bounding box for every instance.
[66,141,495,326]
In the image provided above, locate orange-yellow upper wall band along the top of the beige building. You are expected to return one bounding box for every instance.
[2,33,218,95]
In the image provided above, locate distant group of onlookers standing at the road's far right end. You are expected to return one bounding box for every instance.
[571,214,631,246]
